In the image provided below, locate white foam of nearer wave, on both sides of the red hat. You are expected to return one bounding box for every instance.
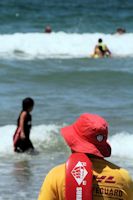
[0,124,133,159]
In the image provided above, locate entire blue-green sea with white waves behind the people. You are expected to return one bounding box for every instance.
[0,0,133,200]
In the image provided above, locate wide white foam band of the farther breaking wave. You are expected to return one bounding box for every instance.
[0,32,133,59]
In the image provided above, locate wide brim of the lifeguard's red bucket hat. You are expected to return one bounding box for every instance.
[61,125,111,158]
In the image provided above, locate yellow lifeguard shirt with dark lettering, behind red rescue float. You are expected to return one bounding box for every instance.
[38,158,133,200]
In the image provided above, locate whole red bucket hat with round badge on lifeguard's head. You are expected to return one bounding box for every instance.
[61,113,111,158]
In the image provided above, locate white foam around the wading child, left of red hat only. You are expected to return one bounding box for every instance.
[0,125,59,156]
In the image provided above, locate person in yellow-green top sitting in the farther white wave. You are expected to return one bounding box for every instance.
[92,38,111,58]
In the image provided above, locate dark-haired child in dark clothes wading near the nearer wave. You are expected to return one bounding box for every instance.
[13,97,34,153]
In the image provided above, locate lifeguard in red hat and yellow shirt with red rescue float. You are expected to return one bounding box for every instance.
[38,113,133,200]
